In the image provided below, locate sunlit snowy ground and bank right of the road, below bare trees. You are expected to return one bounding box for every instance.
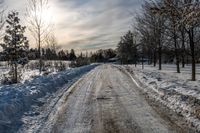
[125,66,200,131]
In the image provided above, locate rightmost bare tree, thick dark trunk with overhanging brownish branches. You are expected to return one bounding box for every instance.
[151,0,200,81]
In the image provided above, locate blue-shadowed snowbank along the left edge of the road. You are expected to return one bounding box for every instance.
[0,64,97,131]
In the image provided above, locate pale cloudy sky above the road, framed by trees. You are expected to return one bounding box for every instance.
[4,0,143,50]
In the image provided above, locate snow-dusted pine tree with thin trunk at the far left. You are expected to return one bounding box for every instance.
[2,11,29,83]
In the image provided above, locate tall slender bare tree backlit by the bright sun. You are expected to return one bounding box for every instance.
[27,0,51,73]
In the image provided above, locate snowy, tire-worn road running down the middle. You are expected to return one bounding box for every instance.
[28,65,188,133]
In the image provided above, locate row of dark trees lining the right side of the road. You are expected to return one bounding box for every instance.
[118,0,200,81]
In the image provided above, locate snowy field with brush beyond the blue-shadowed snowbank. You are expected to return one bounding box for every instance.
[0,60,70,84]
